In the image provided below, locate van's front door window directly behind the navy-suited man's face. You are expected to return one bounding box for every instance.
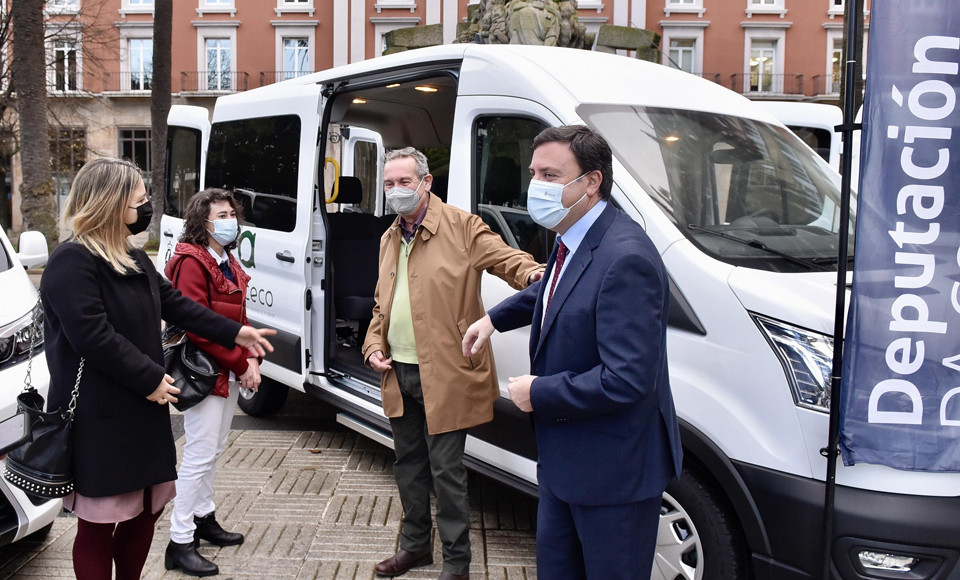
[474,117,554,262]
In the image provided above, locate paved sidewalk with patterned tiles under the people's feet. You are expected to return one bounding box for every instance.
[0,392,536,580]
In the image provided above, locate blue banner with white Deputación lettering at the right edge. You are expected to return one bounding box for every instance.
[839,0,960,471]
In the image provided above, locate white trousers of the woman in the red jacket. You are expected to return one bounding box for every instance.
[170,382,240,544]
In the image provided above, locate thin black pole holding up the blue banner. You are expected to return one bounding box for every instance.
[820,0,863,580]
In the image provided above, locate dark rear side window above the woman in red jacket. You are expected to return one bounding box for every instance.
[206,115,300,232]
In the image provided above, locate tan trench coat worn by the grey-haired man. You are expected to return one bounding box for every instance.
[363,194,543,435]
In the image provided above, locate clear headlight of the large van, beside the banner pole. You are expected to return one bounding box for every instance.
[752,314,833,413]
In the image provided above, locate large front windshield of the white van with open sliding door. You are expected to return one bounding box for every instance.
[578,104,854,272]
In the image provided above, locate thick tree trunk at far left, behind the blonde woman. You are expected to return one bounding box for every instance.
[10,0,59,248]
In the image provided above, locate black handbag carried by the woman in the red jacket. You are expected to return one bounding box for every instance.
[163,325,220,411]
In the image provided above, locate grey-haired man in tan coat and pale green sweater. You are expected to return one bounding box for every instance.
[363,147,543,580]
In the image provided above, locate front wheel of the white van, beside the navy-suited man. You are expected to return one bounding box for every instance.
[651,467,749,580]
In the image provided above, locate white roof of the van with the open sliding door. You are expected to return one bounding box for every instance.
[222,44,777,123]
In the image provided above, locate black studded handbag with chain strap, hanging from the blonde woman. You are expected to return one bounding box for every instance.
[3,300,84,499]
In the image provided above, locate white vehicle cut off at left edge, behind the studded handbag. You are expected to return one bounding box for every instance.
[0,228,62,546]
